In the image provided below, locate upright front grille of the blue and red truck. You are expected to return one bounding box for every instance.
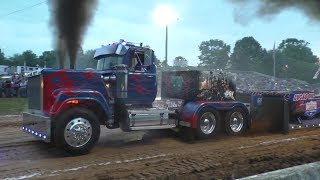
[28,75,42,110]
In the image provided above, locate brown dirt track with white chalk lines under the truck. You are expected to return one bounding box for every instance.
[0,116,320,179]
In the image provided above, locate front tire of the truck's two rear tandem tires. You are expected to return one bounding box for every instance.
[196,108,221,139]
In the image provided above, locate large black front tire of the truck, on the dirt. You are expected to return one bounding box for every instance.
[53,108,100,155]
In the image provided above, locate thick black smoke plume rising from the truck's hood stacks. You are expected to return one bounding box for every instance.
[48,0,97,69]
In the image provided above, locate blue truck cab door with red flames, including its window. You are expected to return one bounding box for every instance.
[128,49,157,104]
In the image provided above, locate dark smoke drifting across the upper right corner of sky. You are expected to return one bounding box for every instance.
[229,0,320,24]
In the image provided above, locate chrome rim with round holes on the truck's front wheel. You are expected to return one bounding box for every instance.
[64,117,92,147]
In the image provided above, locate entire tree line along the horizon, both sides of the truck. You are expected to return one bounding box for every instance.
[0,36,319,82]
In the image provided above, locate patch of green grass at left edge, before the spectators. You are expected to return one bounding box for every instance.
[0,98,27,115]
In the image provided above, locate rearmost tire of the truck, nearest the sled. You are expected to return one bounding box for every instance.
[225,107,248,136]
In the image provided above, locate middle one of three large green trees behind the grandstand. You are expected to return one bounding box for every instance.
[231,36,267,71]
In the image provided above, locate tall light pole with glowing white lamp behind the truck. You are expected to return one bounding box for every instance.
[153,5,178,67]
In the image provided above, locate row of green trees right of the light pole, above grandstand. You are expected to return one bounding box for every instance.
[169,36,319,82]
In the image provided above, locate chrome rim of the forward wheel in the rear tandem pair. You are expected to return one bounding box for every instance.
[200,112,216,135]
